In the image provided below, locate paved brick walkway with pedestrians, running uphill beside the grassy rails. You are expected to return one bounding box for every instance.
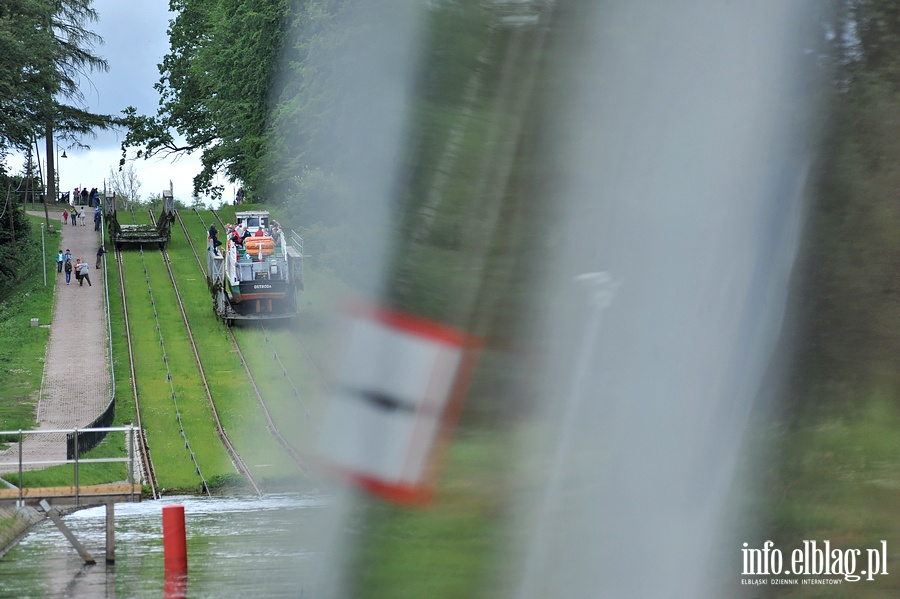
[0,207,110,471]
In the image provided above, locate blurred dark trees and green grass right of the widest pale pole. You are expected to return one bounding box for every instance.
[757,0,900,597]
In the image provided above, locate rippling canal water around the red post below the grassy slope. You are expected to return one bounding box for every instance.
[0,495,328,599]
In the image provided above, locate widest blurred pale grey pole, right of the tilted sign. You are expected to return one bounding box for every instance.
[509,1,821,599]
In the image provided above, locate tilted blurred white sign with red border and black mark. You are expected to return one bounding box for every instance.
[317,307,480,503]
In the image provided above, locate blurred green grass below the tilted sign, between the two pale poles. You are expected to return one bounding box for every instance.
[348,435,508,599]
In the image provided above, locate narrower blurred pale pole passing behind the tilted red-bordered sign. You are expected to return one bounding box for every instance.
[287,0,425,599]
